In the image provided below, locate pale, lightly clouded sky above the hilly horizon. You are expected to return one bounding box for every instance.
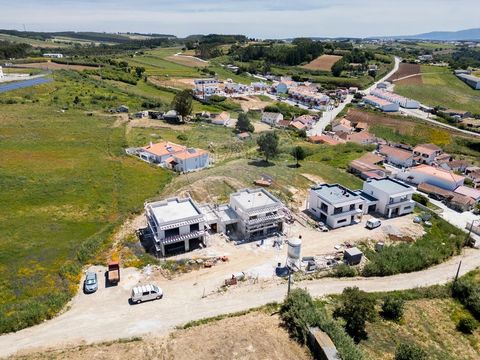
[0,0,480,38]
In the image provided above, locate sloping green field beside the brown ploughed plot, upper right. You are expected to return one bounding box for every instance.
[395,66,480,114]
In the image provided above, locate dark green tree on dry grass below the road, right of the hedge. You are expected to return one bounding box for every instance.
[333,287,375,343]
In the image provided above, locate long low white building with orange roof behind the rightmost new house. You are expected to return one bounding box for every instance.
[396,165,465,191]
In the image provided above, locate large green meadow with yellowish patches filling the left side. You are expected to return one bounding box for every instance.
[0,75,171,332]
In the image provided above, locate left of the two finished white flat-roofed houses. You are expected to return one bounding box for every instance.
[307,184,366,229]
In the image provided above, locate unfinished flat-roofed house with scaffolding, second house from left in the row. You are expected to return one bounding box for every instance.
[229,188,285,240]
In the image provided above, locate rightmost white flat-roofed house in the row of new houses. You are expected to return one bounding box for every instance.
[363,177,415,218]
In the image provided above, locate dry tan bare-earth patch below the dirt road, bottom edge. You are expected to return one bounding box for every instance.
[12,312,312,360]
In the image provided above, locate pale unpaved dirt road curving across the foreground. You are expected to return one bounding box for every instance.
[0,249,480,356]
